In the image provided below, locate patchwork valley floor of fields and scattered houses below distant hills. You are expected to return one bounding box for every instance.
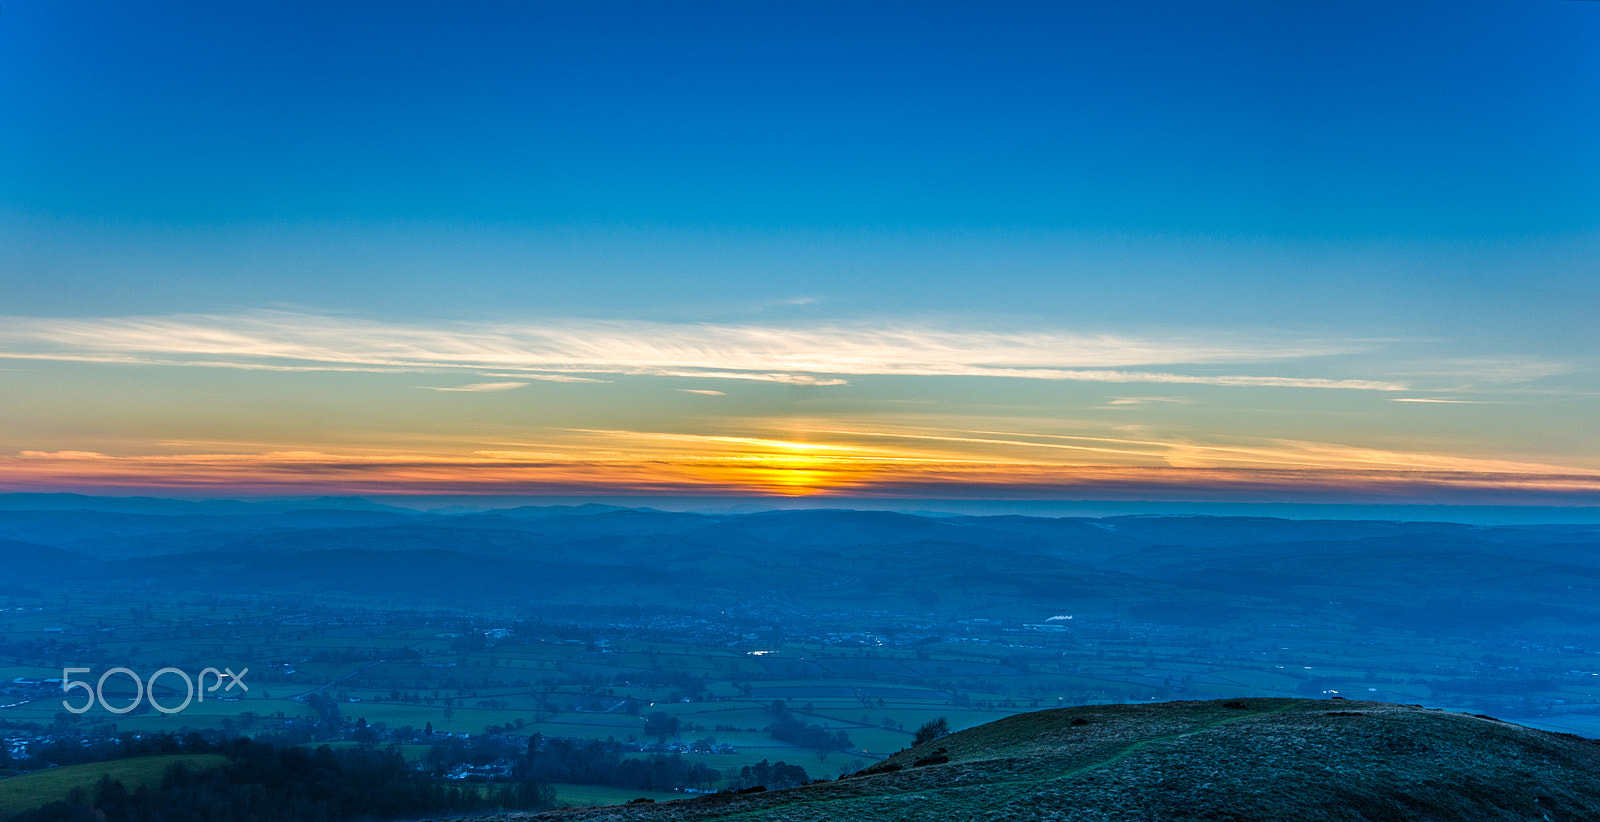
[12,585,1600,776]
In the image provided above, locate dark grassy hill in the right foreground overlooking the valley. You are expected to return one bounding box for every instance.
[470,699,1600,822]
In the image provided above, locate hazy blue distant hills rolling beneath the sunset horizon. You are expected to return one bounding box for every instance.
[0,494,1600,635]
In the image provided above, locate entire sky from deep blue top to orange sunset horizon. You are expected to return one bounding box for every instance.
[0,0,1600,505]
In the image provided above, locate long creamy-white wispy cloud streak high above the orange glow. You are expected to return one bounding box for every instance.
[0,312,1406,390]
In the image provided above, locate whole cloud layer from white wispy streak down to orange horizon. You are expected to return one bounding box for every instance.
[0,312,1580,501]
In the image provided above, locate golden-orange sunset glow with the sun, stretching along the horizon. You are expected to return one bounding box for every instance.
[0,421,1600,499]
